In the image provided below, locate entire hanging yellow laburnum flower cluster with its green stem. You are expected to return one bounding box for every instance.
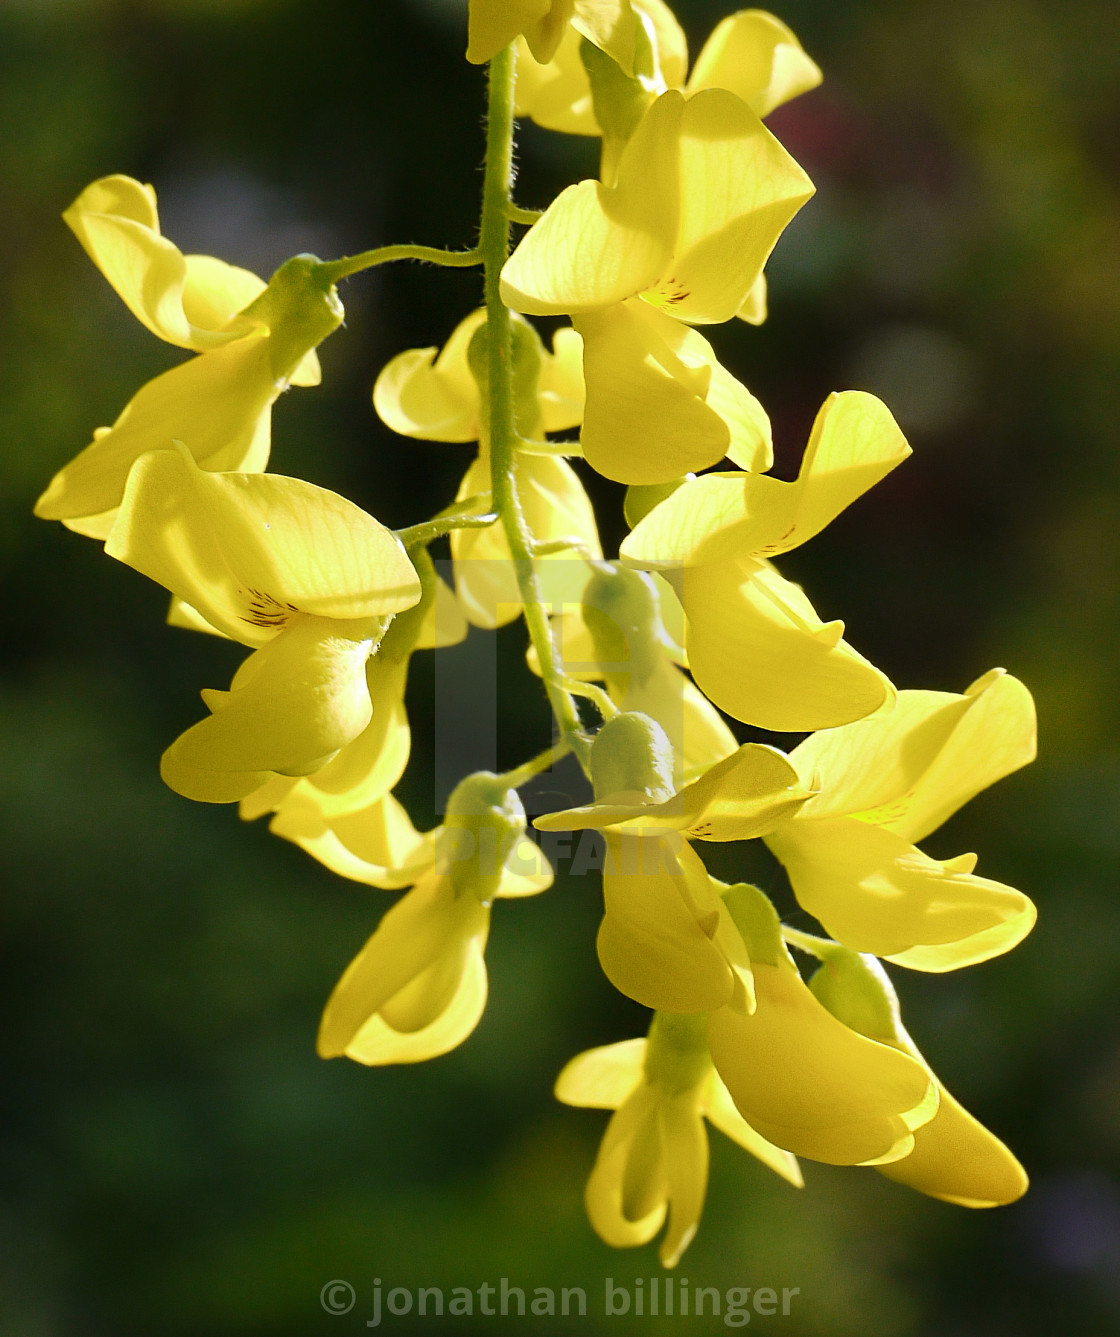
[37,0,1034,1266]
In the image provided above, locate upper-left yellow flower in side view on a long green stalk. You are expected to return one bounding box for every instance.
[35,176,342,539]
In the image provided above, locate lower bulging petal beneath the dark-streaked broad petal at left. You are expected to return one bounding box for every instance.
[160,616,374,802]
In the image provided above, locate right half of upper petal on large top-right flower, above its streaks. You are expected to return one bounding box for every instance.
[644,88,814,324]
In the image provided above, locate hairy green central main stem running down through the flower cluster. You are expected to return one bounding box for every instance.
[478,47,591,770]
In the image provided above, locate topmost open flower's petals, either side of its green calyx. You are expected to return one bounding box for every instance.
[517,0,822,135]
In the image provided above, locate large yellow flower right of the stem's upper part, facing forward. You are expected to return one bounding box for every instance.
[501,88,813,483]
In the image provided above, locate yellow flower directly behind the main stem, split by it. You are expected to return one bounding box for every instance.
[373,310,601,628]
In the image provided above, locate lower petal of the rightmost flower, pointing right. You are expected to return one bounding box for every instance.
[766,817,1034,971]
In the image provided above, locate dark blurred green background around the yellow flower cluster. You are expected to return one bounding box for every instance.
[0,0,1120,1337]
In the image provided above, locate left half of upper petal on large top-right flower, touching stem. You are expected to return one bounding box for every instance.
[501,94,684,316]
